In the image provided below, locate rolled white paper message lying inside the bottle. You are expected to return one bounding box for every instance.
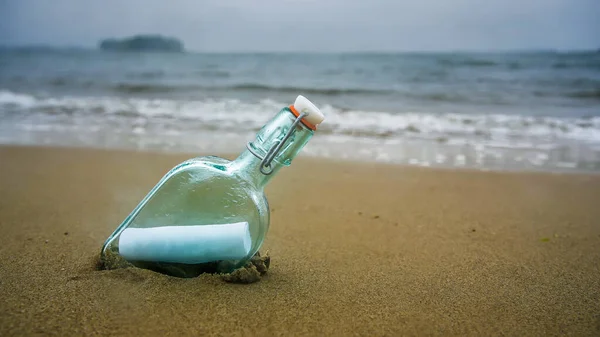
[119,222,252,264]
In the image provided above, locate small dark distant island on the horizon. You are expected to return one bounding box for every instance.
[99,35,184,53]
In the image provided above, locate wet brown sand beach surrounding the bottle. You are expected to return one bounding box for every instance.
[0,147,600,336]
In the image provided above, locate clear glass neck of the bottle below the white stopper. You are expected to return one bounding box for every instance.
[232,108,313,189]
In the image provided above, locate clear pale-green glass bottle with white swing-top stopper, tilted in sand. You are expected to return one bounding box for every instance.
[101,96,324,277]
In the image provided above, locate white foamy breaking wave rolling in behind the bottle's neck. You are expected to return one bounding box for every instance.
[0,91,600,142]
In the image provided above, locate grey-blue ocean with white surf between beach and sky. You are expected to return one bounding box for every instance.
[0,48,600,172]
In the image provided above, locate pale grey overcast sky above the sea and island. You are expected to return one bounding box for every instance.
[0,0,600,51]
